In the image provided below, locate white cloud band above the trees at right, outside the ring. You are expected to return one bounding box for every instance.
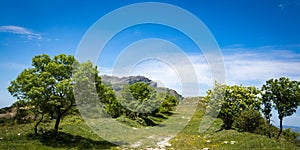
[224,47,300,87]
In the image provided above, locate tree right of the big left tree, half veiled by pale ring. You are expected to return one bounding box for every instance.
[72,62,123,118]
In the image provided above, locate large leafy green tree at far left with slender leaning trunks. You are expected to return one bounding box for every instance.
[8,54,78,135]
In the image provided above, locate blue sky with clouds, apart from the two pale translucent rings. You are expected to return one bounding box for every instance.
[0,0,300,126]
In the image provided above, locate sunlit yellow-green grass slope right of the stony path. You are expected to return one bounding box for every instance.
[171,100,300,150]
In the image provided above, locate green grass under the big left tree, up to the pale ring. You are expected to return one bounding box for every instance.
[0,116,116,150]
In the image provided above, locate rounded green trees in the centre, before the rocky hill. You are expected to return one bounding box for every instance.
[120,82,179,125]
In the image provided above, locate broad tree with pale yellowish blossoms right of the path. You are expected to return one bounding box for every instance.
[204,83,261,129]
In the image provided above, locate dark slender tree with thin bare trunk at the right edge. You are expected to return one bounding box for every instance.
[262,77,300,139]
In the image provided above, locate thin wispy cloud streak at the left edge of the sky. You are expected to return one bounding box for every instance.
[0,25,42,40]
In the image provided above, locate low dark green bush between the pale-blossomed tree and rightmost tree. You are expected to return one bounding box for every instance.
[234,109,264,133]
